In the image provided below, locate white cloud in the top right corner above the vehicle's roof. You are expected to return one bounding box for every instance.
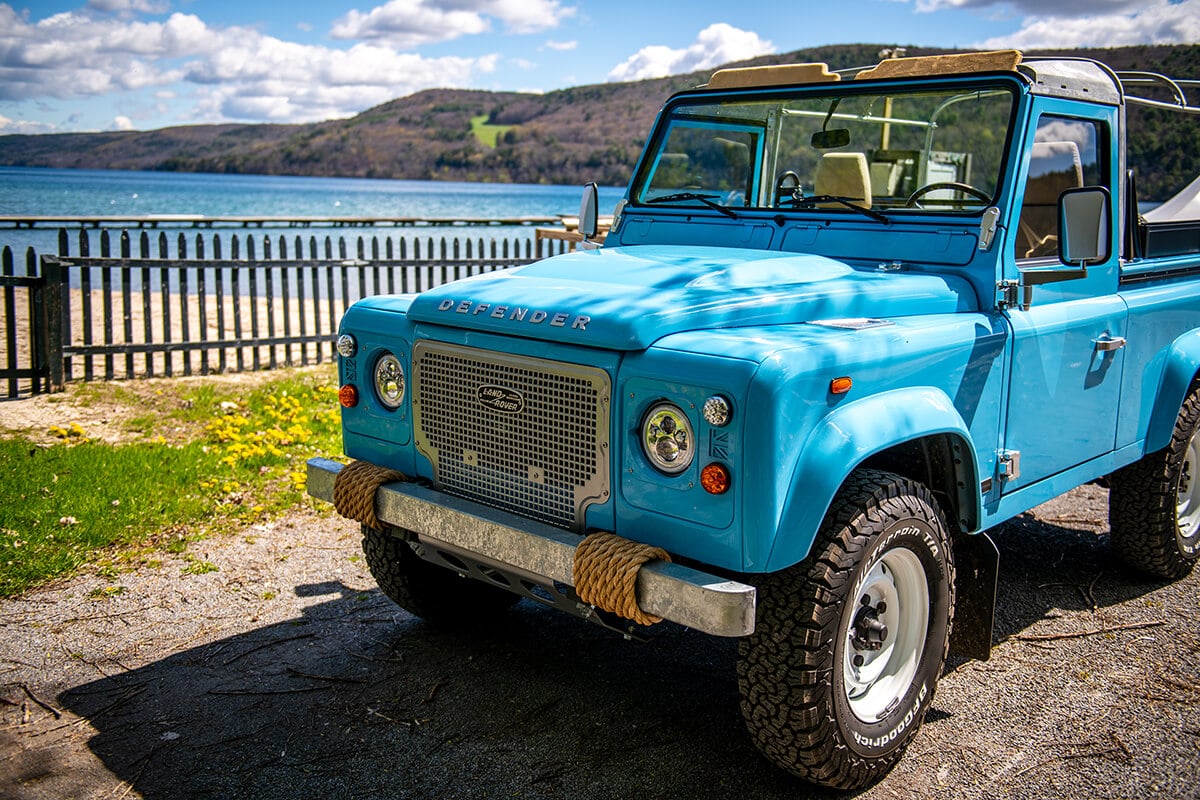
[976,0,1200,50]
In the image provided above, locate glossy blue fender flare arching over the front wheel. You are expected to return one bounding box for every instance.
[767,386,979,572]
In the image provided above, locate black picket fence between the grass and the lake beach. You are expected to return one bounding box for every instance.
[0,229,569,397]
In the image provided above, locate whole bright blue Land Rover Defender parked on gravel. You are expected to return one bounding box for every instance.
[310,52,1200,788]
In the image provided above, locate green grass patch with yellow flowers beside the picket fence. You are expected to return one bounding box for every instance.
[0,373,341,596]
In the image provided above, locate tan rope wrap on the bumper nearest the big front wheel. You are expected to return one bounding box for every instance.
[571,534,671,625]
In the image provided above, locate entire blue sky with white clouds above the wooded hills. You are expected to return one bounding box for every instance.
[0,0,1200,134]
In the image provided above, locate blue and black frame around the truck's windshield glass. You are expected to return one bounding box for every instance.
[628,73,1026,219]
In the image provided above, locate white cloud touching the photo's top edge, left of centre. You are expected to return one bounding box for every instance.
[330,0,575,48]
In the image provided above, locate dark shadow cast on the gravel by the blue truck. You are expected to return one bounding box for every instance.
[59,501,1160,799]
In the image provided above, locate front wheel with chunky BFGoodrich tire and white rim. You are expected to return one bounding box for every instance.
[738,470,954,789]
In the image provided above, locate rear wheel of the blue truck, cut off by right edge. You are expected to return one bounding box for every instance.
[1109,385,1200,579]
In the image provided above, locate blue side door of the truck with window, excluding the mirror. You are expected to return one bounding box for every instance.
[1001,109,1128,494]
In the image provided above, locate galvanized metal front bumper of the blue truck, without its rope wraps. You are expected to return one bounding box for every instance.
[308,458,756,637]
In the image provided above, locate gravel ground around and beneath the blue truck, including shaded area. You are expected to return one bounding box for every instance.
[0,487,1200,800]
